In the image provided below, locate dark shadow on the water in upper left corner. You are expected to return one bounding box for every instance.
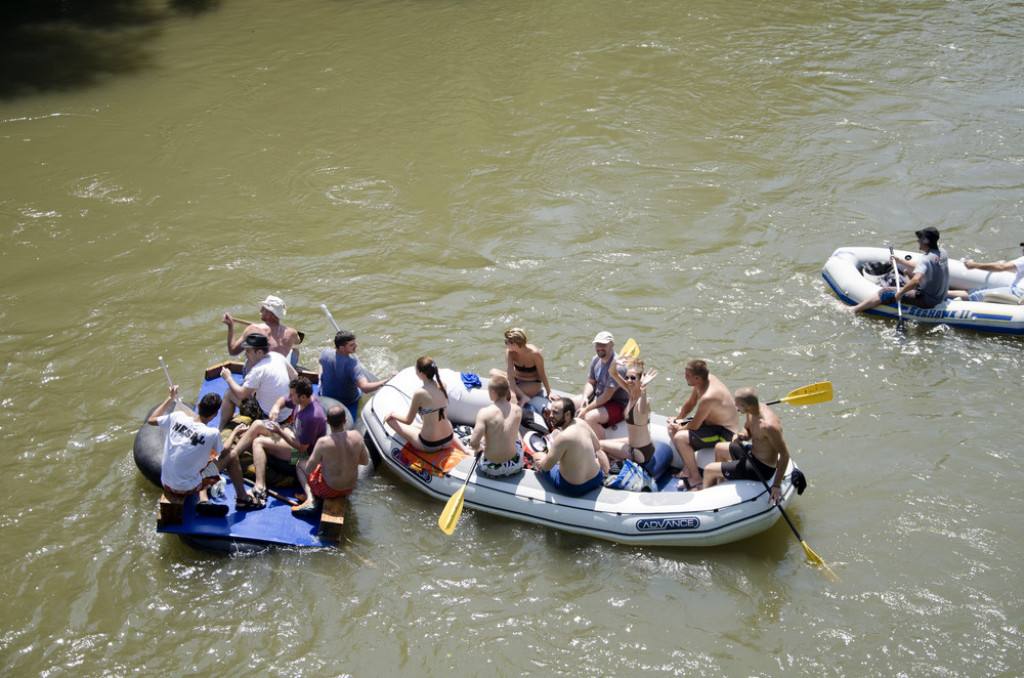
[0,0,219,99]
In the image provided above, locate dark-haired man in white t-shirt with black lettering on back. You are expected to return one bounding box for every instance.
[146,386,260,511]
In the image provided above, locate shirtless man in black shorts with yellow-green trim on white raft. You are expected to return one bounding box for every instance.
[669,361,739,490]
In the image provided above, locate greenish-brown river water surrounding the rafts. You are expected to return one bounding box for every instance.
[0,0,1024,677]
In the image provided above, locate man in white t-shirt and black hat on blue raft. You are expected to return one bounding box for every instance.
[220,334,298,430]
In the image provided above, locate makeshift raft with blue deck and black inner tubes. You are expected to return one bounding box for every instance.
[132,362,373,553]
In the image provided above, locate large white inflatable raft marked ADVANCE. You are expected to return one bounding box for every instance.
[361,368,796,546]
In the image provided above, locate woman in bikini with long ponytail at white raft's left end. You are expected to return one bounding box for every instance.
[384,355,462,452]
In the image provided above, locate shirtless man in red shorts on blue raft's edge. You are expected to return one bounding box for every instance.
[292,405,370,517]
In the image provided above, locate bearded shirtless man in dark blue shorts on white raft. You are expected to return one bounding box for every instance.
[534,397,608,497]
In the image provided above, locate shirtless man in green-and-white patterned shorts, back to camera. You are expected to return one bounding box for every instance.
[469,375,523,478]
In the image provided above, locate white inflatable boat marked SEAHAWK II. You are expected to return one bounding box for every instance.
[821,247,1024,335]
